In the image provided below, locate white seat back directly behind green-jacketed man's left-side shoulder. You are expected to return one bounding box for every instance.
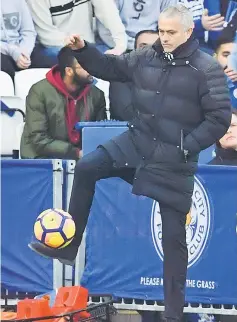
[15,68,49,105]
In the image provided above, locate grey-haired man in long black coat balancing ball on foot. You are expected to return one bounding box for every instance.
[30,5,231,322]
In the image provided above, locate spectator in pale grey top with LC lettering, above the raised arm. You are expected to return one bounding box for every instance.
[97,0,178,50]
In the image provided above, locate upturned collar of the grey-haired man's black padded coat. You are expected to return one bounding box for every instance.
[152,36,199,60]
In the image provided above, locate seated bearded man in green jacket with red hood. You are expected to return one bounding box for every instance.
[21,47,106,160]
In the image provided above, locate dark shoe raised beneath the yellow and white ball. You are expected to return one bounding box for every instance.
[28,242,78,266]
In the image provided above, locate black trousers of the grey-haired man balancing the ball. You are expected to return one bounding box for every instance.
[69,148,188,321]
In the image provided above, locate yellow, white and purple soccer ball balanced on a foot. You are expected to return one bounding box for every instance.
[34,209,76,248]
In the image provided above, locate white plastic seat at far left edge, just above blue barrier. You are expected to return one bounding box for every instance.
[0,96,25,158]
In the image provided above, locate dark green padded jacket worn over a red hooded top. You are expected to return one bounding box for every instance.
[20,79,106,160]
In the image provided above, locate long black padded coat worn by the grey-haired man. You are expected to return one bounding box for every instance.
[75,39,231,212]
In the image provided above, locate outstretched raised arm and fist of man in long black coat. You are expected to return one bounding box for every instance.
[67,35,139,82]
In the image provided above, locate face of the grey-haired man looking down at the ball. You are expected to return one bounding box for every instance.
[159,15,192,53]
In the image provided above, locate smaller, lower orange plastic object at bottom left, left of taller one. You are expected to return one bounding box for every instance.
[16,299,53,322]
